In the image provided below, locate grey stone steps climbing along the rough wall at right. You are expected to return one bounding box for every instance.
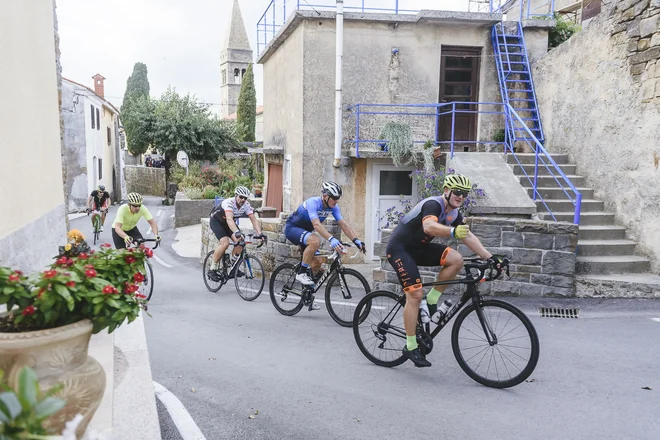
[506,153,660,298]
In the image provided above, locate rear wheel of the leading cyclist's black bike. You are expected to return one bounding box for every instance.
[353,290,407,367]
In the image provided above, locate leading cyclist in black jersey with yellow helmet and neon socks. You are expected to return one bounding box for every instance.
[387,174,501,367]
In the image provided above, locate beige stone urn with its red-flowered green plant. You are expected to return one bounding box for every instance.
[0,229,153,437]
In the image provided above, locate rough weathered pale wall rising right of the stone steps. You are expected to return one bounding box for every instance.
[533,1,660,272]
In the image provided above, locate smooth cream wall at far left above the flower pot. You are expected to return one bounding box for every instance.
[0,0,66,271]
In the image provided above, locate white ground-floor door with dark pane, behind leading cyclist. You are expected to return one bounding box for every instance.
[371,165,417,260]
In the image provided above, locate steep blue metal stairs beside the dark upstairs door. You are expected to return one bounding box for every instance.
[492,22,545,143]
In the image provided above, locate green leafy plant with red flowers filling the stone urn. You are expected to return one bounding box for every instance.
[0,229,153,333]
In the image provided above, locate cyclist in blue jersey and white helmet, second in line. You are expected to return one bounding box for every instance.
[284,182,367,310]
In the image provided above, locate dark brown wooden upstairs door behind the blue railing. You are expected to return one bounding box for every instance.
[438,46,481,151]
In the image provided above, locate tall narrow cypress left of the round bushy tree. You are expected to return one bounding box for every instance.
[121,63,152,155]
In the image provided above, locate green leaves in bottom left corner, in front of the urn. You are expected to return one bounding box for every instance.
[0,366,66,439]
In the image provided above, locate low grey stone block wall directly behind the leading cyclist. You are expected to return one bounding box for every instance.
[373,217,578,297]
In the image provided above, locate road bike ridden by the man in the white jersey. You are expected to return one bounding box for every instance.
[202,234,268,301]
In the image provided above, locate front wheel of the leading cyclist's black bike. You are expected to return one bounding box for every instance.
[451,299,539,388]
